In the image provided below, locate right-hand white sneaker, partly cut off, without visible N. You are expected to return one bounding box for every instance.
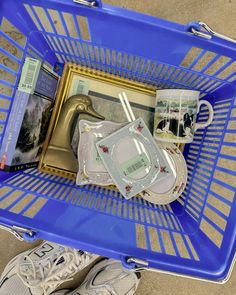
[52,259,141,295]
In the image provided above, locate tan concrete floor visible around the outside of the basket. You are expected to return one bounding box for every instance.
[0,0,236,295]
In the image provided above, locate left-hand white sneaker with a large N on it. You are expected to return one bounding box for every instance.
[0,242,98,295]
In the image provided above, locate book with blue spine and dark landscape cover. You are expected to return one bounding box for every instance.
[0,57,59,172]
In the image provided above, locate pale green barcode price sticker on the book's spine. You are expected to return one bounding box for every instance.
[18,57,41,93]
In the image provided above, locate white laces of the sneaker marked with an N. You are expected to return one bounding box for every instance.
[17,250,90,295]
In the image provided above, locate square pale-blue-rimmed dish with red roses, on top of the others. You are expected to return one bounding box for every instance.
[96,118,172,199]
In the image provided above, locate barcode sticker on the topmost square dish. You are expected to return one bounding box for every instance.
[121,153,150,177]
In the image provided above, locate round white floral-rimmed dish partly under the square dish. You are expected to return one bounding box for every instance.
[139,142,188,205]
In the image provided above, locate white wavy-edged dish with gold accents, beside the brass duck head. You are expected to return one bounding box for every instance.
[76,120,126,185]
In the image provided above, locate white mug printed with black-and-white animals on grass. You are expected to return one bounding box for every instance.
[153,89,214,143]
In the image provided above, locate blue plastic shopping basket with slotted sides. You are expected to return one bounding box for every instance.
[0,0,236,281]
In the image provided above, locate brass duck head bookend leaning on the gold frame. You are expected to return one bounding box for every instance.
[43,95,105,173]
